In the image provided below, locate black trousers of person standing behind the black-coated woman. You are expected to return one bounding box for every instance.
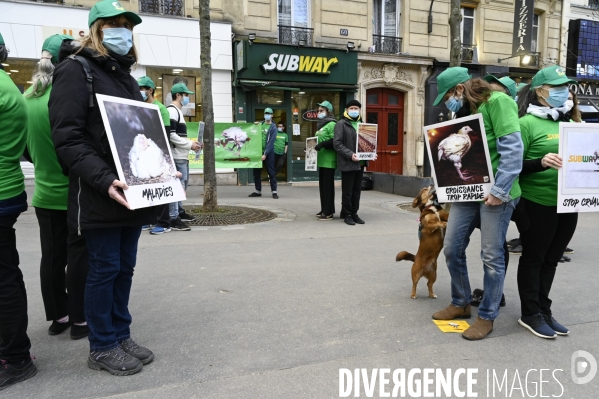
[35,208,88,323]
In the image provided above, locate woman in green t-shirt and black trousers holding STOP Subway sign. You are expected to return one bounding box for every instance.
[518,65,578,338]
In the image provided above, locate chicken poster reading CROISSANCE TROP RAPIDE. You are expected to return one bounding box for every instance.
[424,114,495,202]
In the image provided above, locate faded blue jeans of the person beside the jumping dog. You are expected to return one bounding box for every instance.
[443,199,518,320]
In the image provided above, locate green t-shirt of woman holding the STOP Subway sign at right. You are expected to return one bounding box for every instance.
[520,115,559,206]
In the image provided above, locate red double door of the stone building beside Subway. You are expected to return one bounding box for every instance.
[366,89,404,175]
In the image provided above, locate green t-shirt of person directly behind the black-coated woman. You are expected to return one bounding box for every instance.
[25,85,69,211]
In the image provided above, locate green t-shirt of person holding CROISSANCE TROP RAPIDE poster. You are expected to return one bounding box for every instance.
[478,91,522,199]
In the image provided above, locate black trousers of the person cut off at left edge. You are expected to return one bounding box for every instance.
[0,213,31,363]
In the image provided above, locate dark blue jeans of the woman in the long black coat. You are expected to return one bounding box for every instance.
[84,226,141,351]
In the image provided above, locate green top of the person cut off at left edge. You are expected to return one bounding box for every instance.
[0,70,27,200]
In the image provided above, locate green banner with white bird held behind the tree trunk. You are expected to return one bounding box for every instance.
[187,122,268,169]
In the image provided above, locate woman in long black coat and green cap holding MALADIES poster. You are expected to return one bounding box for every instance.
[49,1,156,375]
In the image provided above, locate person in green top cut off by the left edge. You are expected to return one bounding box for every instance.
[0,35,37,391]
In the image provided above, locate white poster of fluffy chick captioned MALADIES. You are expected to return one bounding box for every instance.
[96,94,185,209]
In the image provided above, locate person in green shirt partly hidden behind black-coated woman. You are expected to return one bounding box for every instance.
[25,35,89,339]
